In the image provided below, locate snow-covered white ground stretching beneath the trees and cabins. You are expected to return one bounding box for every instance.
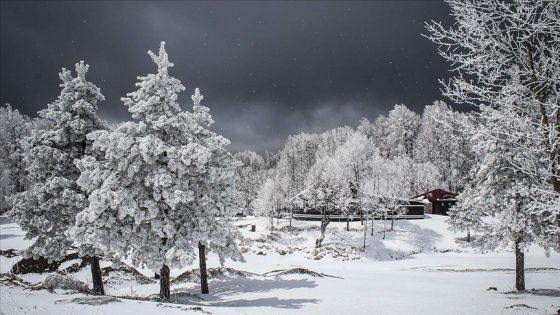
[0,215,560,315]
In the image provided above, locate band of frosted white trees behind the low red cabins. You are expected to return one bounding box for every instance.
[235,101,475,218]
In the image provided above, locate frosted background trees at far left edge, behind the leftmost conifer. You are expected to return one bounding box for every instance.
[0,104,33,213]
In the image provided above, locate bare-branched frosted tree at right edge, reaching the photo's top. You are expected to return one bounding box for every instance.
[427,0,560,237]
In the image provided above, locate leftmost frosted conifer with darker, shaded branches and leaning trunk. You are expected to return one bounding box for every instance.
[8,61,105,294]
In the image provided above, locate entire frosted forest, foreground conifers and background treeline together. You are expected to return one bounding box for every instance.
[0,0,560,314]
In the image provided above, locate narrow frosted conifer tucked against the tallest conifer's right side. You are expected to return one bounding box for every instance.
[183,89,243,294]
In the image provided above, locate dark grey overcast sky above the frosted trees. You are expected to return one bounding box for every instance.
[0,1,460,152]
